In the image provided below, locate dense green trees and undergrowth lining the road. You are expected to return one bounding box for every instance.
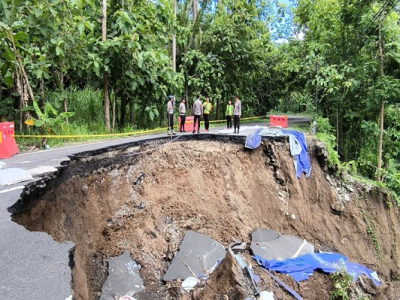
[0,0,400,198]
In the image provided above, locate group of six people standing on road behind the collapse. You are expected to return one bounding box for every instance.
[167,95,242,134]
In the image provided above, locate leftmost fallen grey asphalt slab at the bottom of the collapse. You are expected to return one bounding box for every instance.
[100,251,144,300]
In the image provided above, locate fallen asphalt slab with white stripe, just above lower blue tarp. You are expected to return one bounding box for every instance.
[250,229,314,260]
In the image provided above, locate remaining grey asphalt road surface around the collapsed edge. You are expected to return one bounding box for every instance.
[0,117,311,300]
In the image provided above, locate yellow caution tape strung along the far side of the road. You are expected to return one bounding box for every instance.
[14,117,263,139]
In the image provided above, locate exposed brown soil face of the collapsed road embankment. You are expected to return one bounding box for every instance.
[10,140,400,300]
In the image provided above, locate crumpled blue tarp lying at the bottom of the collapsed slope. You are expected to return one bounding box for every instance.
[253,253,381,286]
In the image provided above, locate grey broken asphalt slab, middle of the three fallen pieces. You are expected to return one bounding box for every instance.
[164,231,226,280]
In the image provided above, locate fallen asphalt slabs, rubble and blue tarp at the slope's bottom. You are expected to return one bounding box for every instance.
[100,229,381,300]
